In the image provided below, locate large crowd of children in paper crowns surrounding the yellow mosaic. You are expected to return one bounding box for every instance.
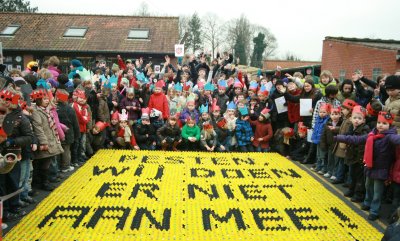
[0,53,400,232]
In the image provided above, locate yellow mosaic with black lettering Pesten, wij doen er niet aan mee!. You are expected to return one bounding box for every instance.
[5,150,383,241]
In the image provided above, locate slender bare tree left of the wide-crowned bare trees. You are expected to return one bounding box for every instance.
[202,13,224,58]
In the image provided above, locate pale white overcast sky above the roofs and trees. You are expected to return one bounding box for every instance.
[30,0,400,60]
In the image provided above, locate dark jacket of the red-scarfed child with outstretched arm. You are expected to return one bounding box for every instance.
[336,127,400,180]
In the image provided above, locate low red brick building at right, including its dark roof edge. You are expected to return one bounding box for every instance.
[322,37,400,81]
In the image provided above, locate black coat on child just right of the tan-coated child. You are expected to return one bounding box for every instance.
[57,102,81,145]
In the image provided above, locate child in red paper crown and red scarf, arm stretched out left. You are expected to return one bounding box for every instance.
[336,112,400,220]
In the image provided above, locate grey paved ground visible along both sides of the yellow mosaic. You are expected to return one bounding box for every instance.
[3,154,390,235]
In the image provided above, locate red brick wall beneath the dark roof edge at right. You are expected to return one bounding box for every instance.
[321,40,400,79]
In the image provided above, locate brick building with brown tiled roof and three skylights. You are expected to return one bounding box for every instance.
[0,13,179,72]
